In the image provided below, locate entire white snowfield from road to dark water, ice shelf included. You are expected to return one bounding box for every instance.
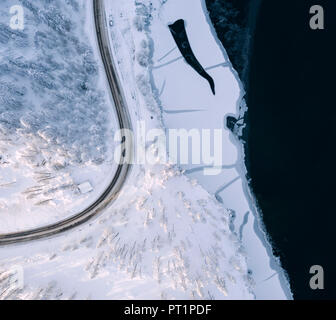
[0,0,292,299]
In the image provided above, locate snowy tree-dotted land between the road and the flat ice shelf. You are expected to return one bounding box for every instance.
[0,1,254,299]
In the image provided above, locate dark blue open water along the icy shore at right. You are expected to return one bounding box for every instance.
[207,0,336,299]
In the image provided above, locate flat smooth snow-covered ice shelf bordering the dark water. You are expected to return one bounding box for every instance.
[107,0,291,299]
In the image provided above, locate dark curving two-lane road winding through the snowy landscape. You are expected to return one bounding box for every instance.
[0,0,133,246]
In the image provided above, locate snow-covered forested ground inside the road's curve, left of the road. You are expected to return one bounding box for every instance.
[0,0,118,233]
